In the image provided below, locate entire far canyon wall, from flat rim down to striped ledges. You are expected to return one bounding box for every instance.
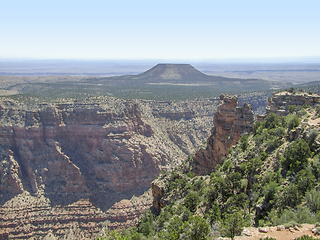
[0,97,216,238]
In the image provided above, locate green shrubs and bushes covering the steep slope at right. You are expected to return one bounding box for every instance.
[99,101,320,240]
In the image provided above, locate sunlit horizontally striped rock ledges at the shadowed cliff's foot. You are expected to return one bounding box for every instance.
[0,191,152,239]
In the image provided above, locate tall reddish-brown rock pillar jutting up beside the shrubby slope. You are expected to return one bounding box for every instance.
[192,94,254,175]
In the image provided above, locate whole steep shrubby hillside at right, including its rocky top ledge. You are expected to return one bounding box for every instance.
[143,92,320,239]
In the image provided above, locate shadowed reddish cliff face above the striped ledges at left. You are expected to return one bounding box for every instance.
[0,98,160,201]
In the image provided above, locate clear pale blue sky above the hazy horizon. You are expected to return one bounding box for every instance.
[0,0,320,60]
